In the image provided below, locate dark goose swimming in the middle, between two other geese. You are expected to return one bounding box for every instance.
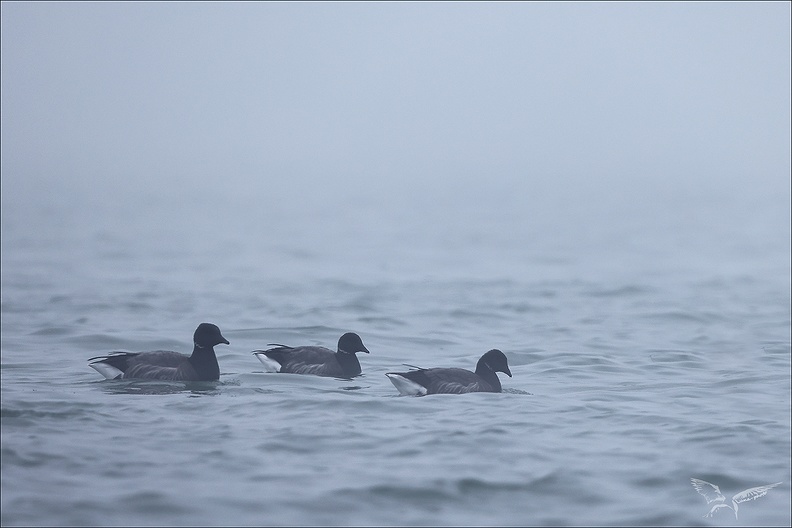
[253,332,369,378]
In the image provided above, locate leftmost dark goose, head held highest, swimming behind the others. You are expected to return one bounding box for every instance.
[88,323,229,381]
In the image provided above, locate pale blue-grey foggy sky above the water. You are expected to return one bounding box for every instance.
[2,2,790,227]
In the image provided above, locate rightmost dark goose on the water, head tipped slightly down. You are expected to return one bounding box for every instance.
[385,349,511,396]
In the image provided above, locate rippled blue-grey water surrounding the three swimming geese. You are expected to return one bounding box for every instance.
[2,180,792,526]
